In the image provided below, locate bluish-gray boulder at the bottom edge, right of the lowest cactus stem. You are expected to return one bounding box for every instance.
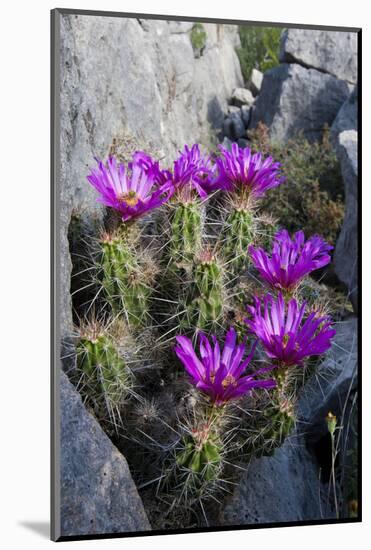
[221,440,334,525]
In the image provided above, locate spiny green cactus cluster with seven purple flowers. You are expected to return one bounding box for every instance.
[68,141,334,528]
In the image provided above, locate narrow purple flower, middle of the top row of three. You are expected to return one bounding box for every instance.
[172,144,215,199]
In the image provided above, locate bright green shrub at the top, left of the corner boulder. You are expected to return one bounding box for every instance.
[237,25,282,81]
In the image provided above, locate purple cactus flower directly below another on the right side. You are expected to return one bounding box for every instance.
[245,294,336,366]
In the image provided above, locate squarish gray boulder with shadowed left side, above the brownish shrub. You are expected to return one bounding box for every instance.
[250,64,351,141]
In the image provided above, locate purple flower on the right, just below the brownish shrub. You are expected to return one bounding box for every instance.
[249,229,333,290]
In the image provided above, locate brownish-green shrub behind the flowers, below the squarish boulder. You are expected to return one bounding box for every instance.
[250,124,344,248]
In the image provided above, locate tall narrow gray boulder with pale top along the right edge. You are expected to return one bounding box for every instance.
[334,130,358,311]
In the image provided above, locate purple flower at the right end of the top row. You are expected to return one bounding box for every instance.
[213,143,285,199]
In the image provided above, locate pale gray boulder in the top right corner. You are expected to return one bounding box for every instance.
[280,29,357,84]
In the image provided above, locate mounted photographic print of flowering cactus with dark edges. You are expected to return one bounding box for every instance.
[52,9,361,540]
